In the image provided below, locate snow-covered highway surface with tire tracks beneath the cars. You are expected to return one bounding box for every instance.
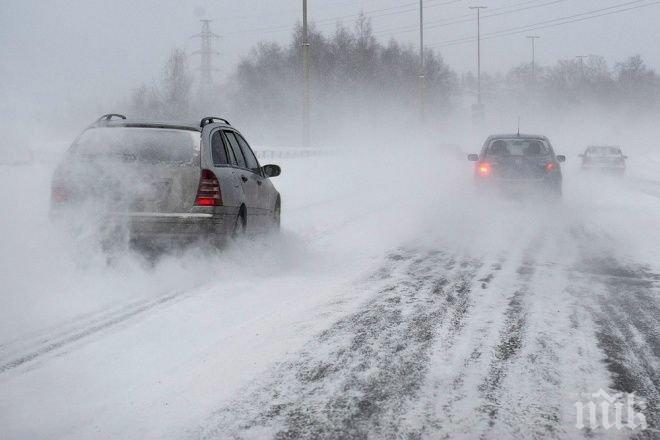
[0,144,660,439]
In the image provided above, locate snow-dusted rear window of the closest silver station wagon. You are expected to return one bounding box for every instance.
[72,127,200,164]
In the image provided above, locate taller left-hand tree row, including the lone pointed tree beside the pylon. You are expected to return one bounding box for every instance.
[131,16,460,141]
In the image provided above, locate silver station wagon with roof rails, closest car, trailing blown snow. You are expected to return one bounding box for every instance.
[51,114,281,245]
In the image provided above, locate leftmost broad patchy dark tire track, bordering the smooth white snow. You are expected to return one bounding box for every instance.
[200,252,480,439]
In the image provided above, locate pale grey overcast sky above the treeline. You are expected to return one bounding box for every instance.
[0,0,660,117]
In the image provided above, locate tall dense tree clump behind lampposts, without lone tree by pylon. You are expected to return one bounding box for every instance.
[224,16,459,139]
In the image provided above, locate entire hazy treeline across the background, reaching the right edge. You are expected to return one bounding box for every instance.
[131,16,660,142]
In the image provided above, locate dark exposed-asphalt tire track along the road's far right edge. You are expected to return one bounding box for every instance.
[573,225,660,440]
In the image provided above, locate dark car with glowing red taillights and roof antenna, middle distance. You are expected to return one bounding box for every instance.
[468,134,566,197]
